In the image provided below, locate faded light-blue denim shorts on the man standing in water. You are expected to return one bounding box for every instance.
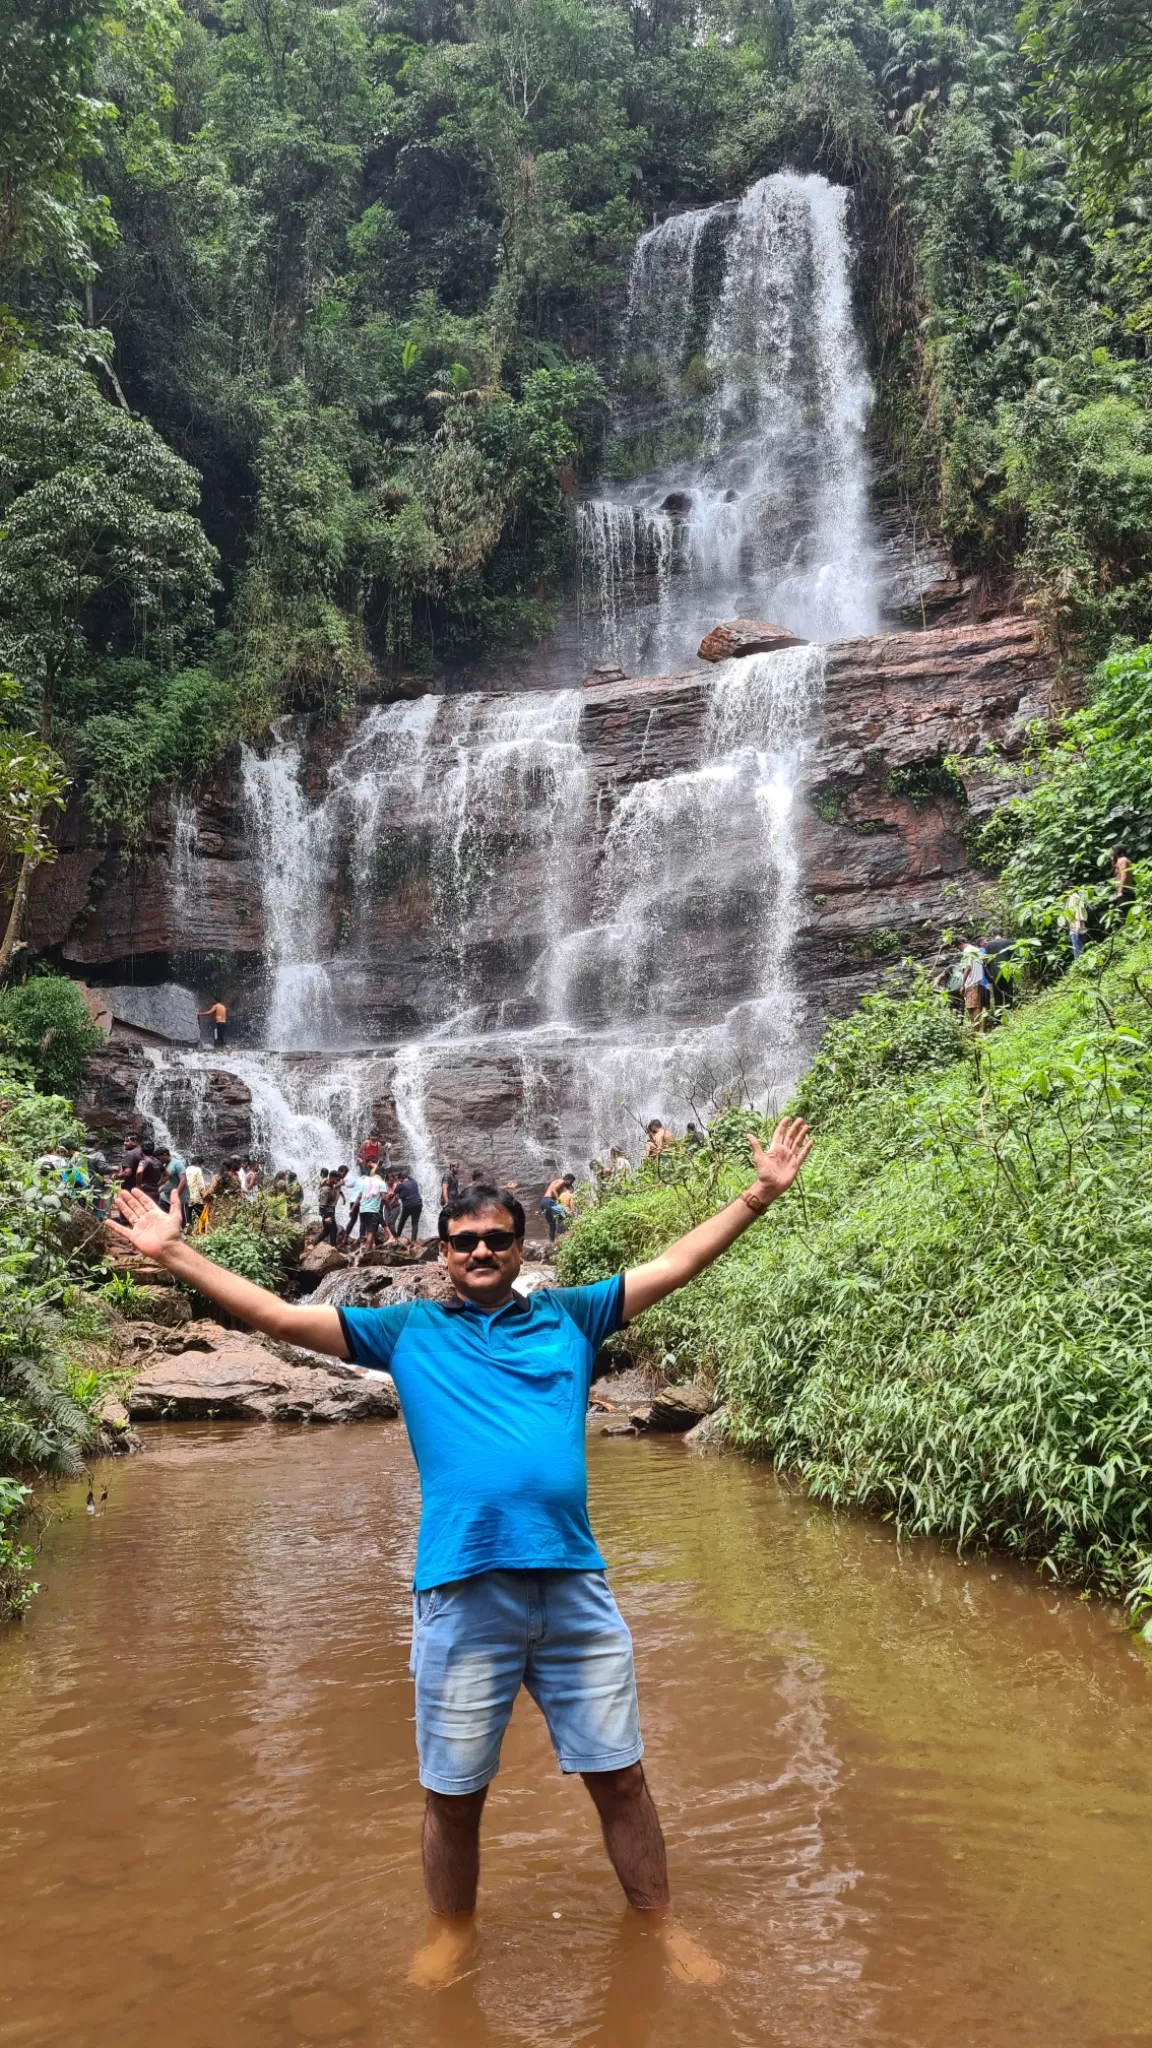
[412,1571,644,1794]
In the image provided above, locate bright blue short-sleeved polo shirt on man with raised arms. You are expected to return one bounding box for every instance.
[338,1274,623,1591]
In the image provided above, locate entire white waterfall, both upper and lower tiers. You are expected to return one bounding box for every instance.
[139,174,875,1202]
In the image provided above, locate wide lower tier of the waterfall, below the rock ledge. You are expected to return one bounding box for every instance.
[137,647,824,1190]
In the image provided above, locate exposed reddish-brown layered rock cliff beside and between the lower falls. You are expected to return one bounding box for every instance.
[58,616,1054,1182]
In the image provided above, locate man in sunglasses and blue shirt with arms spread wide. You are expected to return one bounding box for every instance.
[109,1116,812,1987]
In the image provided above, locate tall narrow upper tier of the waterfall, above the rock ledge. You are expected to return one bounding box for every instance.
[578,172,877,674]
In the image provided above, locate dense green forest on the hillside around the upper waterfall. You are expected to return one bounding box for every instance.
[0,0,1152,858]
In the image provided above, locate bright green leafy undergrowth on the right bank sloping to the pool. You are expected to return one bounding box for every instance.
[562,920,1152,1593]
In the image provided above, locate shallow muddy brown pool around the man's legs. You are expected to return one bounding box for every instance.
[0,1425,1152,2048]
